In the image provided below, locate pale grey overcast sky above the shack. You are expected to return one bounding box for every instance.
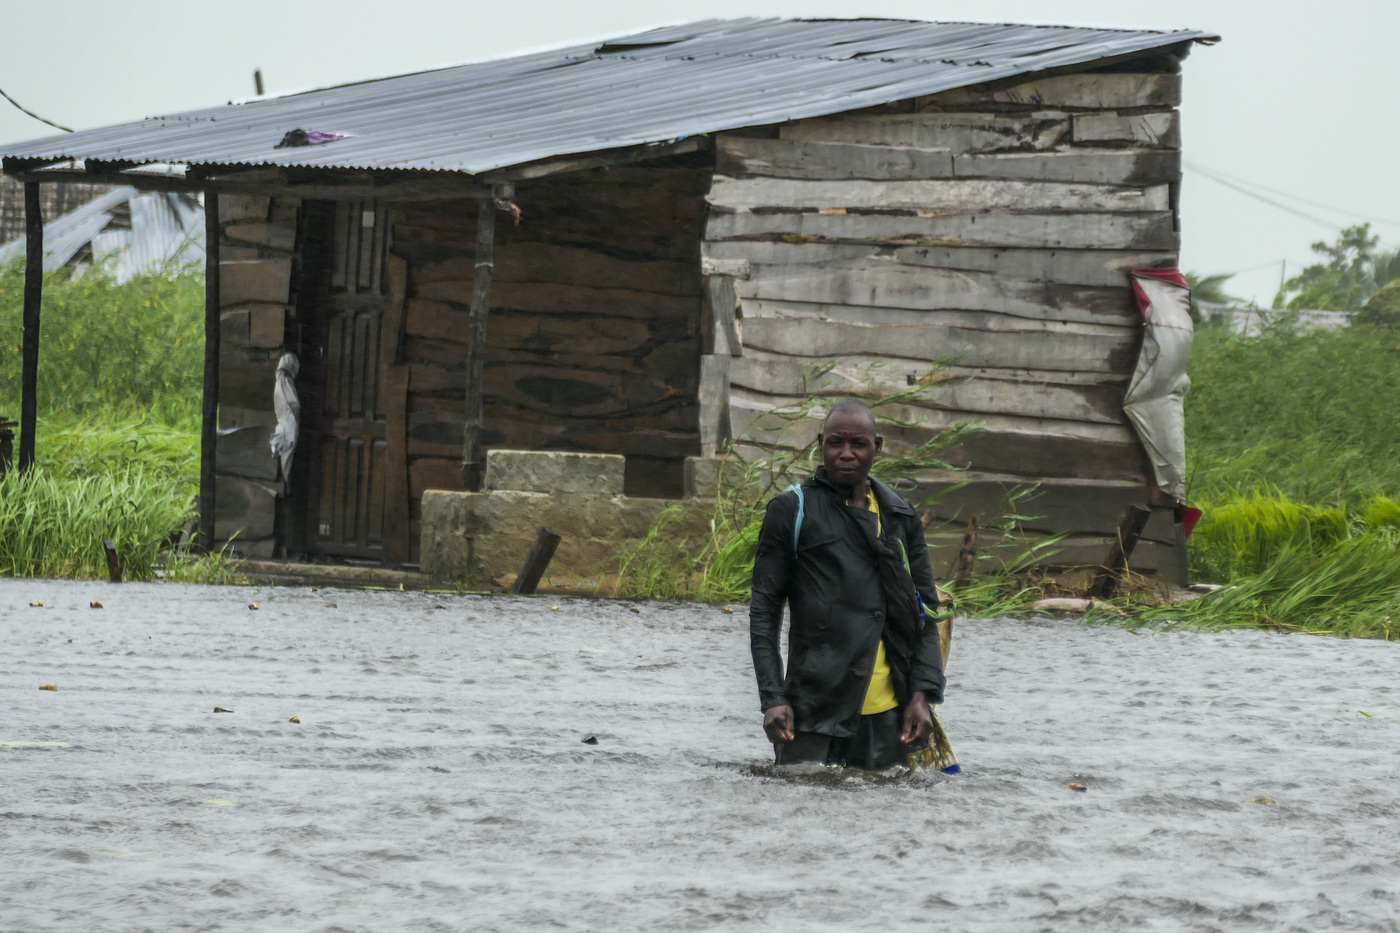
[0,0,1400,303]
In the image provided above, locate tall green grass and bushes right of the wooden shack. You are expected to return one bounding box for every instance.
[1142,305,1400,639]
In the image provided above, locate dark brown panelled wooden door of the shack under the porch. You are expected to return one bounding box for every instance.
[308,202,407,554]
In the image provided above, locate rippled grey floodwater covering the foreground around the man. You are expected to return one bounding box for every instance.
[0,580,1400,933]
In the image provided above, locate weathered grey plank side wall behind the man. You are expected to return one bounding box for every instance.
[701,73,1180,572]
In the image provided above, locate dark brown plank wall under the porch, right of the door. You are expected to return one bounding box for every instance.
[391,158,710,541]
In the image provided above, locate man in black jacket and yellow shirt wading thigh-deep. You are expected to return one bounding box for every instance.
[749,398,944,770]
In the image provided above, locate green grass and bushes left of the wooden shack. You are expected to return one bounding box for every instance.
[0,266,232,581]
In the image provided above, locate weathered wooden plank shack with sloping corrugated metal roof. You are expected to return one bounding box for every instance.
[4,20,1214,577]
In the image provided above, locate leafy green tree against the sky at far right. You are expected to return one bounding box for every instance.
[1274,224,1400,311]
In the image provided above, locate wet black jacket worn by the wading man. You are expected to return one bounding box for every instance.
[749,468,944,737]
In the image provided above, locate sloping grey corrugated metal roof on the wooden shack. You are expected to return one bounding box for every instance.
[4,18,1218,174]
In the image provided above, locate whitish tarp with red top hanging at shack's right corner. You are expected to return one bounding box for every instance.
[1123,269,1194,502]
